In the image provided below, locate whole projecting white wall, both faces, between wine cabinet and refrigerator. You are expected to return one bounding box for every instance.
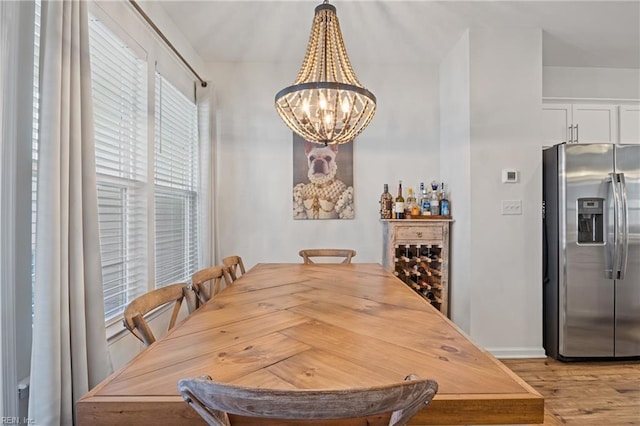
[440,28,544,357]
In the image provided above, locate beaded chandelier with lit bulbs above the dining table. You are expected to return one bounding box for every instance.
[275,0,376,145]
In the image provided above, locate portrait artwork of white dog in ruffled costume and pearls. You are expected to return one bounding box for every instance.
[293,133,354,219]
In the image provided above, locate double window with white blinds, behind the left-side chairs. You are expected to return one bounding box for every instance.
[89,16,199,322]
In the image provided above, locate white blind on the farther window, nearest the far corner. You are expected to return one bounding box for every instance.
[154,73,199,287]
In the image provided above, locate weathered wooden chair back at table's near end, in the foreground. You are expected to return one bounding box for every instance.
[178,374,438,426]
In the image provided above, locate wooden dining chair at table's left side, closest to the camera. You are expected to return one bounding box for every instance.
[122,283,189,346]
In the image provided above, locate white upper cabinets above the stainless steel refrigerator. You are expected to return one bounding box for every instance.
[542,102,640,146]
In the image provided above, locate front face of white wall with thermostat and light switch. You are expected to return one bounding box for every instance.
[469,28,543,356]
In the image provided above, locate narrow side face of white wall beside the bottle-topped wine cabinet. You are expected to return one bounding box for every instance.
[440,31,472,333]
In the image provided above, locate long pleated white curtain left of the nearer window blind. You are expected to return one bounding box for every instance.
[29,0,111,425]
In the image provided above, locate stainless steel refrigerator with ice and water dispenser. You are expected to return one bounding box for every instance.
[543,143,640,360]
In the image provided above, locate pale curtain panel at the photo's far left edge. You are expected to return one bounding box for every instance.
[0,1,34,423]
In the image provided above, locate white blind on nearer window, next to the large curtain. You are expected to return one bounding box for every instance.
[89,16,148,321]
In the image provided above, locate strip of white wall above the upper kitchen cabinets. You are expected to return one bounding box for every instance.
[542,66,640,99]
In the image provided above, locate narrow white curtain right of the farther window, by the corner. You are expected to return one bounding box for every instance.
[195,82,217,268]
